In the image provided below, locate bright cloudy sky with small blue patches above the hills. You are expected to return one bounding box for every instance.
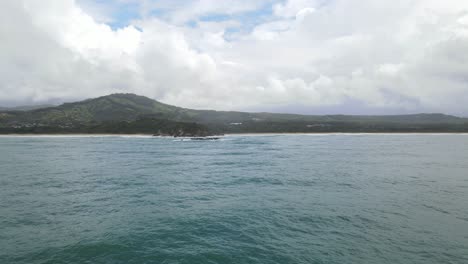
[0,0,468,116]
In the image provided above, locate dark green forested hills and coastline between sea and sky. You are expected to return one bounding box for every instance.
[0,94,468,135]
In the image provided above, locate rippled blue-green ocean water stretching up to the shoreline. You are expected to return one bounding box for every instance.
[0,134,468,264]
